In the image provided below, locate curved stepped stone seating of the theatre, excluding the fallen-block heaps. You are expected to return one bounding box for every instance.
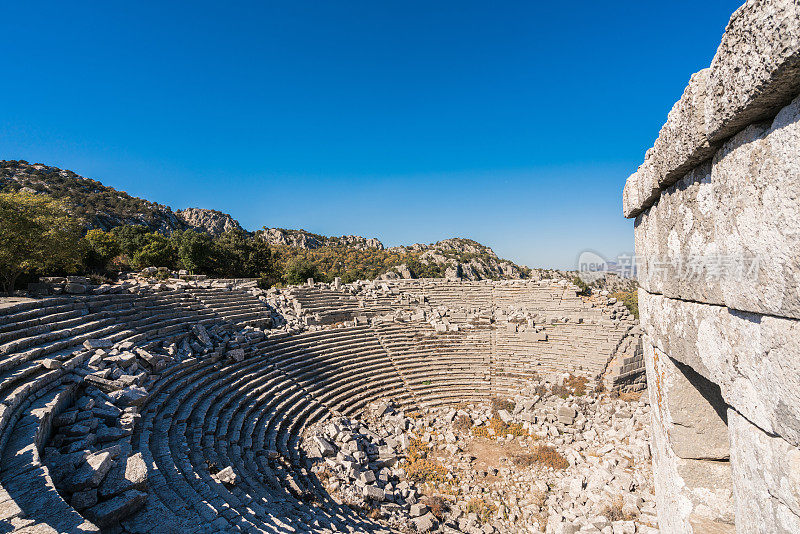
[0,280,641,533]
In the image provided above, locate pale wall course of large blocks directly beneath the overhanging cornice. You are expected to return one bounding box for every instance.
[635,97,800,318]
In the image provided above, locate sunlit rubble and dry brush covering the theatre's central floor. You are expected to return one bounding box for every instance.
[302,376,658,534]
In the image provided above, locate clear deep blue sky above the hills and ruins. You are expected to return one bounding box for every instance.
[0,0,741,268]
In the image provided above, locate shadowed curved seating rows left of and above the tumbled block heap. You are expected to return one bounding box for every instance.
[0,290,256,532]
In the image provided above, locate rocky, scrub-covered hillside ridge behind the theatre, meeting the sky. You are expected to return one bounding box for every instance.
[0,160,531,280]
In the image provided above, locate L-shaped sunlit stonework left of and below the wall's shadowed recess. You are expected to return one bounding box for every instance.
[644,339,734,533]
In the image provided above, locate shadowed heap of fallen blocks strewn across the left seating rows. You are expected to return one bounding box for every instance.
[43,324,245,527]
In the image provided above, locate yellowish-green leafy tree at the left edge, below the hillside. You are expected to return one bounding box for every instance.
[0,192,81,293]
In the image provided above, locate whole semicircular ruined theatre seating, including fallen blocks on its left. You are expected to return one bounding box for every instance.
[0,277,643,532]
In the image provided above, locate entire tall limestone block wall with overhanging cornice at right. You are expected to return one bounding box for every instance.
[623,0,800,534]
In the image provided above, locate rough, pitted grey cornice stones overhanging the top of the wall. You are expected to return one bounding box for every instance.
[622,0,800,217]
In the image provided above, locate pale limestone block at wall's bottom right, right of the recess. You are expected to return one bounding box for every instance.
[728,410,800,534]
